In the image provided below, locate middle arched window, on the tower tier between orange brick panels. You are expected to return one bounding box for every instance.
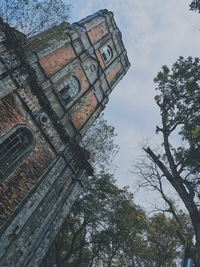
[57,76,81,103]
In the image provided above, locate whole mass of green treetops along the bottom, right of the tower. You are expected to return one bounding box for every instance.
[49,173,181,267]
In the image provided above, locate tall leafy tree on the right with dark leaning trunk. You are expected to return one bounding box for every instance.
[141,57,200,266]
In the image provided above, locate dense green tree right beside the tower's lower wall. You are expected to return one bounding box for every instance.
[56,174,145,266]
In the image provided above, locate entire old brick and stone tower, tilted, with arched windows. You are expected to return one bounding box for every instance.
[0,10,130,267]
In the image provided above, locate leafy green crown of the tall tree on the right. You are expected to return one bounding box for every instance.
[154,57,200,184]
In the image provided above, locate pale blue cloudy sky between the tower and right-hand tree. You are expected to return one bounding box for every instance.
[69,0,200,207]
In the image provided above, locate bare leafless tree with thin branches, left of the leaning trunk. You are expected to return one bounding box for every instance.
[135,155,194,246]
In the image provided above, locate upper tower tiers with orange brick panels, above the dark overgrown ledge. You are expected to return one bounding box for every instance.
[21,9,130,140]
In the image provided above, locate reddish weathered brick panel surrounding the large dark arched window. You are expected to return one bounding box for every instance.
[0,92,55,225]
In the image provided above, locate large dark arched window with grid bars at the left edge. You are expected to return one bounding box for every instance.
[0,125,35,181]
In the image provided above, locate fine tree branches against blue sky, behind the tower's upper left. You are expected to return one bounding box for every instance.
[0,0,71,36]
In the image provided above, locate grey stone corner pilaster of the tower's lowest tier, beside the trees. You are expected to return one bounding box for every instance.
[0,151,87,267]
